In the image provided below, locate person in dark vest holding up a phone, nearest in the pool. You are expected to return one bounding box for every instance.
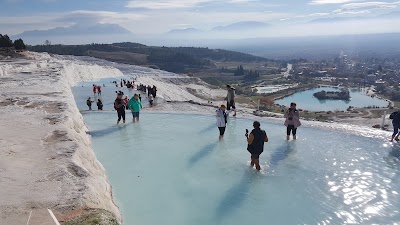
[245,121,268,171]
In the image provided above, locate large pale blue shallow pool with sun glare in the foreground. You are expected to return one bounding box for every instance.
[84,112,400,225]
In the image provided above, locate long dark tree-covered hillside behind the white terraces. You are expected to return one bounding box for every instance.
[29,42,267,73]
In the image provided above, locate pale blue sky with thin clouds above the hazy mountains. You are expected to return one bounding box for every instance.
[0,0,400,34]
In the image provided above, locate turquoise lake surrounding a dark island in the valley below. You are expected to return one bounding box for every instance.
[275,87,389,111]
